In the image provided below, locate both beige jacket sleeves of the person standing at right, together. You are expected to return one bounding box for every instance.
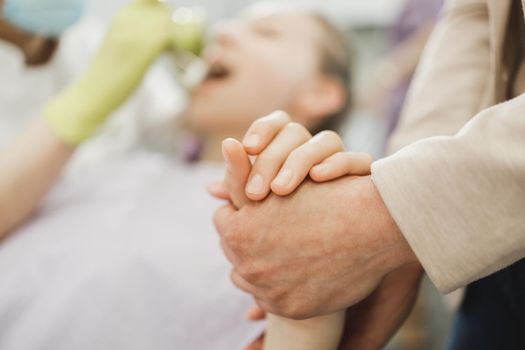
[372,0,525,292]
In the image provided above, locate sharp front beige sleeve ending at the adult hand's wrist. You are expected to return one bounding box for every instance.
[372,94,525,292]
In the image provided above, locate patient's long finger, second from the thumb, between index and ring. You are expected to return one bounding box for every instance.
[246,123,312,200]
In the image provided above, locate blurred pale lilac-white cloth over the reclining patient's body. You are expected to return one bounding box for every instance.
[0,155,262,350]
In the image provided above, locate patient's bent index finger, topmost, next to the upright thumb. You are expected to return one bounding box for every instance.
[242,111,291,155]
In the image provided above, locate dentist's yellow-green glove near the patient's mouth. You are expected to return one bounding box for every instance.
[44,0,203,146]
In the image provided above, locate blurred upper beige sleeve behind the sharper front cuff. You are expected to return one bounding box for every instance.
[389,0,491,152]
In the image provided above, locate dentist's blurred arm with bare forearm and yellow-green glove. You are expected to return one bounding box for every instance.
[0,0,178,239]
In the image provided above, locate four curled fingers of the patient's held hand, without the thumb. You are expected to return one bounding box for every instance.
[239,112,372,200]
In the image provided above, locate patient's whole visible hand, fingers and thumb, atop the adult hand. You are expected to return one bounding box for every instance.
[210,112,372,208]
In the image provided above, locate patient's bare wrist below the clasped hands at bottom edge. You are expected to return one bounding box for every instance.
[264,310,345,350]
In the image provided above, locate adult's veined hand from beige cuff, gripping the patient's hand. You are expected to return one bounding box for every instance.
[215,176,417,319]
